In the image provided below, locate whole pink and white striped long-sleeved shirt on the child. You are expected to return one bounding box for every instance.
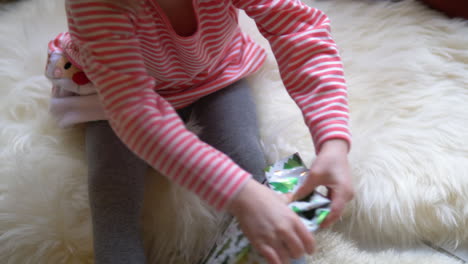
[57,0,350,209]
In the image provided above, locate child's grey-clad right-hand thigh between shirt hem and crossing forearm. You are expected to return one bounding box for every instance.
[193,80,266,183]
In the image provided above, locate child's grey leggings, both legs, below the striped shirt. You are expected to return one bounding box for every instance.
[86,80,266,264]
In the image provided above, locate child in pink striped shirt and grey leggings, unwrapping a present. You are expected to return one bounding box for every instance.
[47,0,352,264]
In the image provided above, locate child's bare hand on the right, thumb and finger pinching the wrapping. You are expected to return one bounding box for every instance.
[294,139,354,227]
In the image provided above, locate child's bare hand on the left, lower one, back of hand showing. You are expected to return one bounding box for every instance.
[228,179,315,264]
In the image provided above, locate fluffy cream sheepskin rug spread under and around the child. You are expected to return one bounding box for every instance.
[0,0,468,264]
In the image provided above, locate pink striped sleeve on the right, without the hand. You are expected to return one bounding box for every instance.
[232,0,351,152]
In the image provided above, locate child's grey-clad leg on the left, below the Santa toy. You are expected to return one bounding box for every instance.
[86,121,148,264]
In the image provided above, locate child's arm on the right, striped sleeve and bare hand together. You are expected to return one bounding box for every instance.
[234,0,353,225]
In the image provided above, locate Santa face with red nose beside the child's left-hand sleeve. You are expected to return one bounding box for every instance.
[46,52,96,97]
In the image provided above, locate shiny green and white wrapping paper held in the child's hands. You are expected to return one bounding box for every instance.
[200,153,330,264]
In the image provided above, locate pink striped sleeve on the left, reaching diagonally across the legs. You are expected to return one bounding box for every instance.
[67,0,251,210]
